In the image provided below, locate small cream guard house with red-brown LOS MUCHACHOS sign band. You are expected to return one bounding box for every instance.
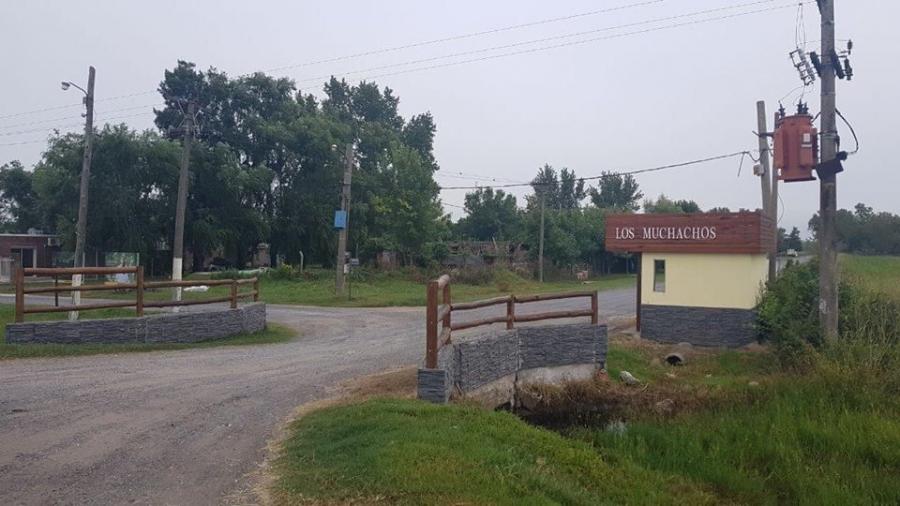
[606,211,775,346]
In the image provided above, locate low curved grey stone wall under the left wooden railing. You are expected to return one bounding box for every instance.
[6,302,266,344]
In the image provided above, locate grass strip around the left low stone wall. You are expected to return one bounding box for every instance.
[0,304,296,360]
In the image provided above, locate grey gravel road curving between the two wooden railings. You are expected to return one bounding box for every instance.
[0,289,634,505]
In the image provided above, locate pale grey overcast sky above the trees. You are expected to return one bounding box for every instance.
[0,0,900,235]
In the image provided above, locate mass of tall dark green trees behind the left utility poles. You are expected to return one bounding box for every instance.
[0,62,449,266]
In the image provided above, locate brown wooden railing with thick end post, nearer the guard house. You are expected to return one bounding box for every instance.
[425,274,600,369]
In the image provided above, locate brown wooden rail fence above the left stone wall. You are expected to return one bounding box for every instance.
[15,267,259,322]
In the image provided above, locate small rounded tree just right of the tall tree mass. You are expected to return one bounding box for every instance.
[457,187,521,241]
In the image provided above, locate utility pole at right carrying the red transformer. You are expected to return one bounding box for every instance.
[819,0,840,339]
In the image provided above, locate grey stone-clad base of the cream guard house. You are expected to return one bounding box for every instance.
[641,304,756,347]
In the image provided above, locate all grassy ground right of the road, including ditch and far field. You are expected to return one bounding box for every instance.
[272,256,900,505]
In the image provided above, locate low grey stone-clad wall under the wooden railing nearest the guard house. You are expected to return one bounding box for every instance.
[418,323,607,403]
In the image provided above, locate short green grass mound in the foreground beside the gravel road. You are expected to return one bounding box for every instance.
[274,399,712,505]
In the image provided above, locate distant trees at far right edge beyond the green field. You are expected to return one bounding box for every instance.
[809,203,900,255]
